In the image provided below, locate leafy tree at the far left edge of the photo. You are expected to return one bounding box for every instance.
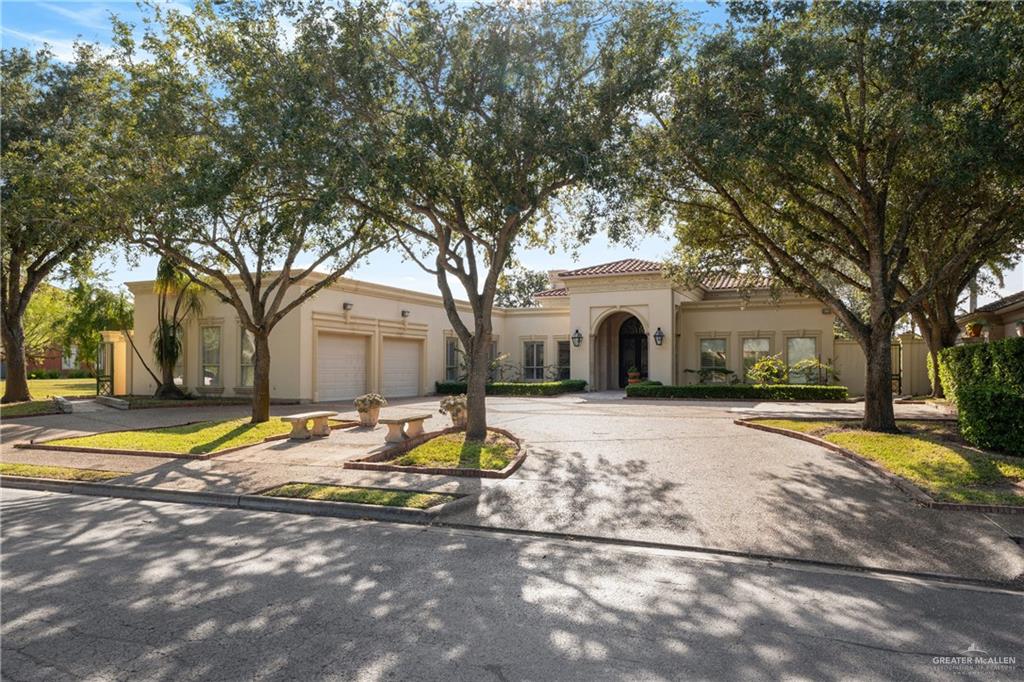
[0,45,127,402]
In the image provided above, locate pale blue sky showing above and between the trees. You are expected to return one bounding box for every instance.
[0,0,1024,300]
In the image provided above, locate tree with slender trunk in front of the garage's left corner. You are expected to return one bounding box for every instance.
[119,1,379,423]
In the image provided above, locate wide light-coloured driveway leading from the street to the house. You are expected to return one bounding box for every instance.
[3,394,1024,581]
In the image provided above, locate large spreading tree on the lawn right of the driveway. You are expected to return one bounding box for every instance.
[636,3,1024,431]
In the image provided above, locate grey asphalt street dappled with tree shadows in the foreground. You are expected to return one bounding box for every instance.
[0,489,1024,681]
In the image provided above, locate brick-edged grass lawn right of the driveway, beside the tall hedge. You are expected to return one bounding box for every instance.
[754,419,1024,505]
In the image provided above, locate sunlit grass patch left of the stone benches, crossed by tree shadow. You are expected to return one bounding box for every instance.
[47,417,319,455]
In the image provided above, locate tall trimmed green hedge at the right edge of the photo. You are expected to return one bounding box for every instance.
[939,337,1024,455]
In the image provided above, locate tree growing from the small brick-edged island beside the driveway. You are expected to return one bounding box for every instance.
[330,0,675,440]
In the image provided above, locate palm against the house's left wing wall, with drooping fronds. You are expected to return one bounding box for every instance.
[152,258,203,399]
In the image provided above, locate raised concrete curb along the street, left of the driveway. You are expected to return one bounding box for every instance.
[0,475,475,525]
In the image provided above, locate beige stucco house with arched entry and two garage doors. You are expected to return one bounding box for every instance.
[102,259,836,401]
